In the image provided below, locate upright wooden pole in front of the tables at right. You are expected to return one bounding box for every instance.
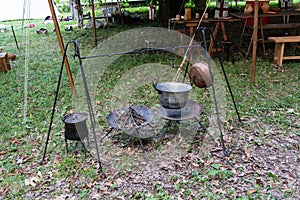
[251,0,259,85]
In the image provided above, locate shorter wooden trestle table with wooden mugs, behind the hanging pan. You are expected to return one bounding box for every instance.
[170,17,241,54]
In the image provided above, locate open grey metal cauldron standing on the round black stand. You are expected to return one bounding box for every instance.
[153,82,192,109]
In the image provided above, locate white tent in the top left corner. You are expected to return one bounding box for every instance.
[0,0,58,21]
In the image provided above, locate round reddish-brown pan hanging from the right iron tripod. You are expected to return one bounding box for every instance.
[190,61,212,88]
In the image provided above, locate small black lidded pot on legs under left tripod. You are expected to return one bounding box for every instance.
[62,113,88,141]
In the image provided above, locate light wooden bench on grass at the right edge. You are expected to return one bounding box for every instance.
[268,36,300,67]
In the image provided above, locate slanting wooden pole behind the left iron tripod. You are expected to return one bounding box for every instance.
[48,0,76,96]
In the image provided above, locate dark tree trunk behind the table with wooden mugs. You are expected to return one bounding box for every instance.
[158,0,206,27]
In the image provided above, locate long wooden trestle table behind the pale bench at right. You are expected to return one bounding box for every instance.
[229,10,300,57]
